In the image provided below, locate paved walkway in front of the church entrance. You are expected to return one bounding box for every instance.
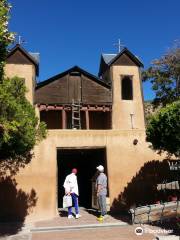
[0,209,180,240]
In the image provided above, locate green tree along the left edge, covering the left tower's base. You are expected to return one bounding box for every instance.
[0,0,46,173]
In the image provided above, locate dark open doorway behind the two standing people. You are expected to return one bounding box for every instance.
[57,148,107,208]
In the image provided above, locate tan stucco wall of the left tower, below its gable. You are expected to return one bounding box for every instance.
[5,64,35,104]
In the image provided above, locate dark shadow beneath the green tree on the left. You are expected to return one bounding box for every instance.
[0,176,37,235]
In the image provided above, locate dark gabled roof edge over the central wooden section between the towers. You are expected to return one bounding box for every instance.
[36,66,110,89]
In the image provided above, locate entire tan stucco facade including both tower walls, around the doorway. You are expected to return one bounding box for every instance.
[5,60,157,221]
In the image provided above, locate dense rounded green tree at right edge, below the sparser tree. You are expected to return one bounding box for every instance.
[146,100,180,157]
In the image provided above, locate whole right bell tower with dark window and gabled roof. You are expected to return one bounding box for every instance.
[99,48,145,130]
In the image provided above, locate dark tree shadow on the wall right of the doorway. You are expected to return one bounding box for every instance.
[111,159,178,213]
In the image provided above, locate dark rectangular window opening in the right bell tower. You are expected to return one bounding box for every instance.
[121,76,133,100]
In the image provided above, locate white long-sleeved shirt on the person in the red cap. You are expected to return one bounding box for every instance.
[63,173,79,196]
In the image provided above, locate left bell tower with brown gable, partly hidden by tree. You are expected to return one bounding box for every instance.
[5,44,39,104]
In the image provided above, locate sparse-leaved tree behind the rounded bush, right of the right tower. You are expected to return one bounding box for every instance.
[142,43,180,107]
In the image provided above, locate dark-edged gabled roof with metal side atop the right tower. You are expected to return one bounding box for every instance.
[98,48,143,76]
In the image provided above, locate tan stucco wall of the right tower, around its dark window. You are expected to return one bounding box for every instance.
[111,66,145,130]
